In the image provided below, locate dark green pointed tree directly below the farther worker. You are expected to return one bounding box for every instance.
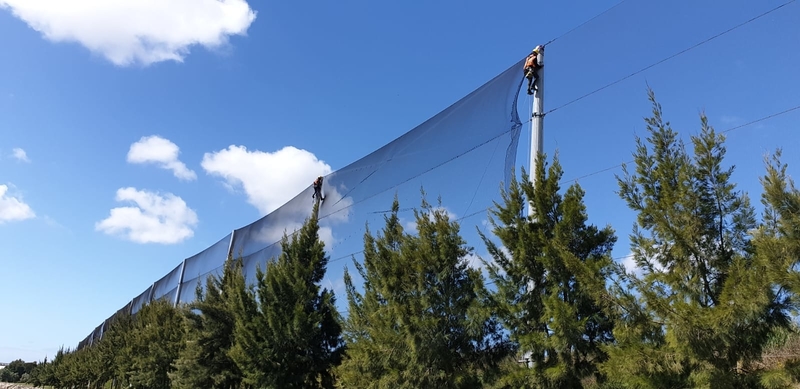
[232,205,343,389]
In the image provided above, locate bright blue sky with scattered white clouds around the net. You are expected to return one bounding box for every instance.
[0,0,800,362]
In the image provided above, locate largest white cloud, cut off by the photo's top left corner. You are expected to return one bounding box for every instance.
[0,0,256,66]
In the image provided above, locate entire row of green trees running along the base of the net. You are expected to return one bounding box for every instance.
[10,91,800,389]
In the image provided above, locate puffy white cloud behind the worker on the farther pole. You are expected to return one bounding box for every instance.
[202,145,332,215]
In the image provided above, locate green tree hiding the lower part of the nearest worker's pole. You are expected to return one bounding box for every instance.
[481,155,616,388]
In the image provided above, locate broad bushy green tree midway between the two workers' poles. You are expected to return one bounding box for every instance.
[337,199,508,388]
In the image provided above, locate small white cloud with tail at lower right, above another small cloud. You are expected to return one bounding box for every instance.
[128,135,197,181]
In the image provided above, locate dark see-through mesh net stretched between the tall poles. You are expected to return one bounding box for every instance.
[79,61,524,348]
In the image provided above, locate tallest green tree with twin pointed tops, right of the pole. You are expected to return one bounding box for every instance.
[603,91,789,388]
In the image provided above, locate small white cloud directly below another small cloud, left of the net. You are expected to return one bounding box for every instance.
[95,188,197,244]
